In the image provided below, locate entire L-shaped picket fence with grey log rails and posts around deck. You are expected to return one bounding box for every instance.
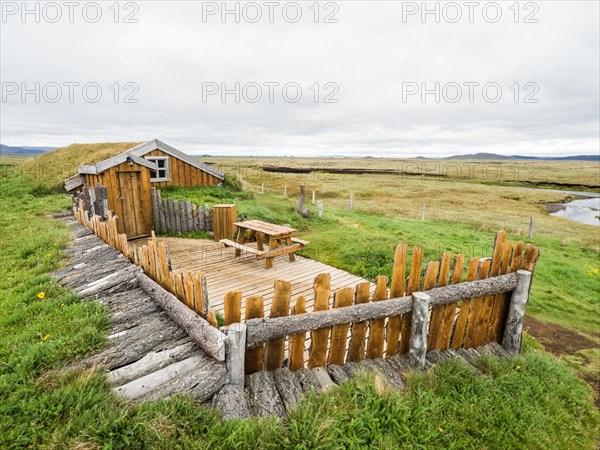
[73,187,540,374]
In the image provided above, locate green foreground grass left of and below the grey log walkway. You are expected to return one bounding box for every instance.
[0,168,600,449]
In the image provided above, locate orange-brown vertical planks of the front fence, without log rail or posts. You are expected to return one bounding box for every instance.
[221,231,540,373]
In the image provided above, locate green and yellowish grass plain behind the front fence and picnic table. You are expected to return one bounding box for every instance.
[164,159,600,332]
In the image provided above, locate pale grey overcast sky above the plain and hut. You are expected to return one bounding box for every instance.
[0,1,600,157]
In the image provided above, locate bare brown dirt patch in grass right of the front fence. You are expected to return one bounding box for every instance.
[524,316,600,409]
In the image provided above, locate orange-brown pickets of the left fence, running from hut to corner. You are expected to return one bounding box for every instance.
[73,194,217,327]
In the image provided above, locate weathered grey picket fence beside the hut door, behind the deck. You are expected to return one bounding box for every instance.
[152,188,213,233]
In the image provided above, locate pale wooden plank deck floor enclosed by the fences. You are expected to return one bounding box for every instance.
[135,237,375,316]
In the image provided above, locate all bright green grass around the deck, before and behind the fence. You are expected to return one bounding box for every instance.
[0,154,600,449]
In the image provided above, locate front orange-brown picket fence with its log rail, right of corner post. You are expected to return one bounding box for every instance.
[224,231,540,374]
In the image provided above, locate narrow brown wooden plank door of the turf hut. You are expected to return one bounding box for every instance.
[117,171,152,239]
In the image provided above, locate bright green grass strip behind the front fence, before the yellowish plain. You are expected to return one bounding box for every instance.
[162,187,600,338]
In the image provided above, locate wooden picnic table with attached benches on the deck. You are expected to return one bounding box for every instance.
[219,220,308,269]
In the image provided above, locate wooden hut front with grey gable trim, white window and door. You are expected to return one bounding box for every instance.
[65,139,224,239]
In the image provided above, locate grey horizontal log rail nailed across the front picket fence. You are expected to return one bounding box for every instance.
[245,272,518,348]
